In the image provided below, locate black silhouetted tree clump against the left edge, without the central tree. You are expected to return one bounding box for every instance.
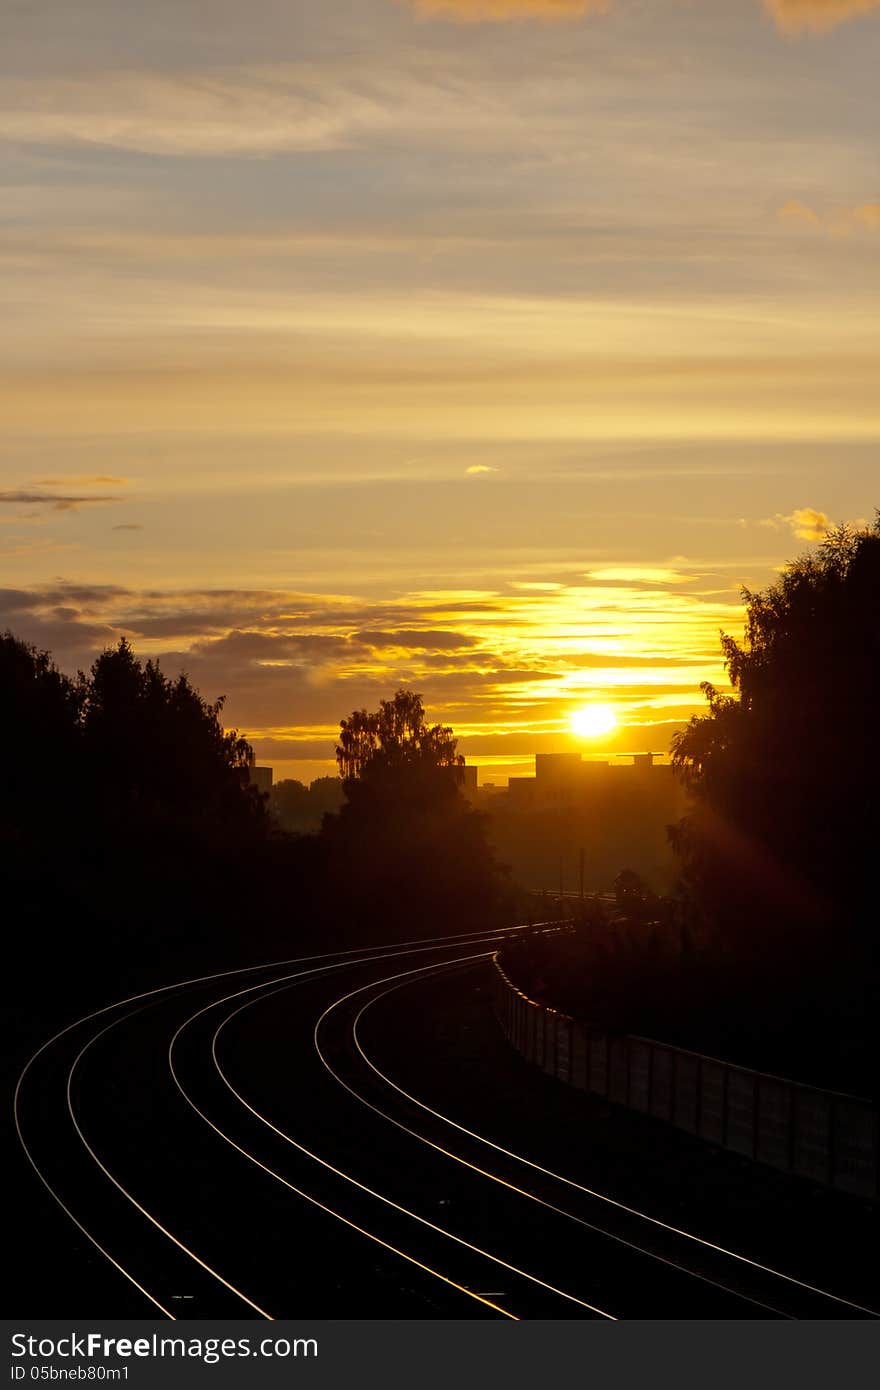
[0,634,298,992]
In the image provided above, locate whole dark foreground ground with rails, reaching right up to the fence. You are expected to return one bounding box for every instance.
[10,934,879,1319]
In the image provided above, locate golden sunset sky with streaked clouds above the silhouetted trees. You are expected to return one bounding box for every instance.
[0,0,880,781]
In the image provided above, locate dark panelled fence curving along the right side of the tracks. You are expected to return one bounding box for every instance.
[495,959,880,1197]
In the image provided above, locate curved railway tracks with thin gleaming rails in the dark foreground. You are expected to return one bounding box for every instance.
[15,929,876,1319]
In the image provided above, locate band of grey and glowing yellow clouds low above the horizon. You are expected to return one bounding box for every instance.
[0,566,738,758]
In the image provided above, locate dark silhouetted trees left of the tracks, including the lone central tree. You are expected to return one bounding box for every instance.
[0,632,506,1028]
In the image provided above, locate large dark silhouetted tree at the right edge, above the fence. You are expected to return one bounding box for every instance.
[671,520,880,945]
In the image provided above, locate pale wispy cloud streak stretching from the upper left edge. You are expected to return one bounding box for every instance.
[0,53,536,158]
